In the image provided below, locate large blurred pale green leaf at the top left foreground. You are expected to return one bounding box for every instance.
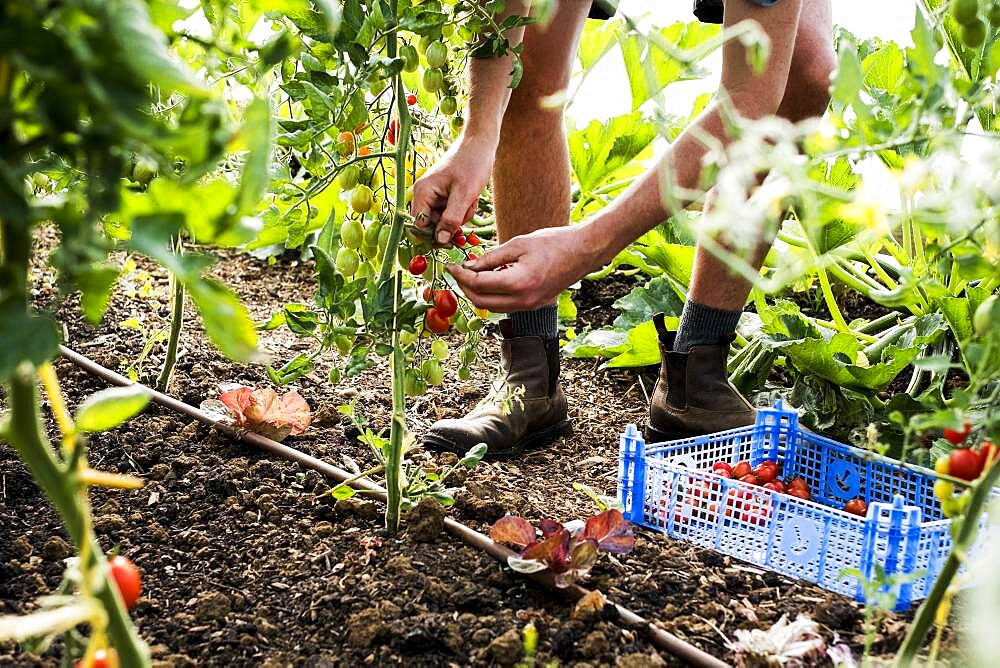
[104,0,208,98]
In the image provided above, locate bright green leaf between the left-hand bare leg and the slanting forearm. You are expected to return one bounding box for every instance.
[569,112,656,192]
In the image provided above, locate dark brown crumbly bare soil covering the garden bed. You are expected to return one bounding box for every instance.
[0,232,936,666]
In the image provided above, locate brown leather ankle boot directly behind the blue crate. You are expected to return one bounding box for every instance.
[644,313,756,443]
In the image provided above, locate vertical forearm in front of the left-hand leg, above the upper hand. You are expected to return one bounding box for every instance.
[464,0,531,140]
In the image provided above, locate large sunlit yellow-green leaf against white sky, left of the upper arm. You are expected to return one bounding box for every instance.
[618,21,719,111]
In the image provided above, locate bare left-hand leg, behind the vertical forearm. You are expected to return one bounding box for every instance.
[493,0,590,242]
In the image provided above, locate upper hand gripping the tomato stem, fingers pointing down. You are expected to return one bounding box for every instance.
[410,135,497,246]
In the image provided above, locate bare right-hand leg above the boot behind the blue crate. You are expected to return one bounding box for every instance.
[688,0,836,311]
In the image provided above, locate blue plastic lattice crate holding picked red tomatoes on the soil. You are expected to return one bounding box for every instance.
[618,402,985,610]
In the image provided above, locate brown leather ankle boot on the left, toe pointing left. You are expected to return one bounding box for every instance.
[424,320,571,459]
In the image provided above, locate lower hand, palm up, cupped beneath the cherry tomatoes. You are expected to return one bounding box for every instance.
[448,225,603,313]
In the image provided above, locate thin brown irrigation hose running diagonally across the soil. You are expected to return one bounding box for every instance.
[59,346,729,668]
